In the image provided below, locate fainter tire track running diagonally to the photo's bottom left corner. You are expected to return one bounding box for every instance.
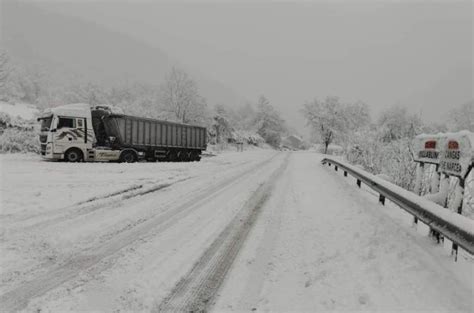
[0,154,279,312]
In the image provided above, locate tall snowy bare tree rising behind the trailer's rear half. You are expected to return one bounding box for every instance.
[161,67,206,123]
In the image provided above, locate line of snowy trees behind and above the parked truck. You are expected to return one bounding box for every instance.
[0,51,287,147]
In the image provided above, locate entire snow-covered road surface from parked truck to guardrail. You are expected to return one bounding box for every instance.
[0,150,473,312]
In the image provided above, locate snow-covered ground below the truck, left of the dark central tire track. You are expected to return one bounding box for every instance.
[0,150,282,310]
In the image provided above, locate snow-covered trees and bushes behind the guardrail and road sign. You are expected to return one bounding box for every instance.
[302,97,474,190]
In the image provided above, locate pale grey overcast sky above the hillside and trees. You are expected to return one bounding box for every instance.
[31,1,473,132]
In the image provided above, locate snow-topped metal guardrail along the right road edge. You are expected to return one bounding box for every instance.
[321,158,474,255]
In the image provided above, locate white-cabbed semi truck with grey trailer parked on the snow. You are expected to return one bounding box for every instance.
[38,103,207,163]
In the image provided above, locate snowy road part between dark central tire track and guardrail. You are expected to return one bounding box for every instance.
[214,153,474,312]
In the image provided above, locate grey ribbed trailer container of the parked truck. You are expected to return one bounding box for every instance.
[93,111,207,161]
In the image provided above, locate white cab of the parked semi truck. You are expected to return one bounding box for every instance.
[38,103,96,162]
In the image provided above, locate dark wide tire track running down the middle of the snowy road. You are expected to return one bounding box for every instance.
[156,154,289,312]
